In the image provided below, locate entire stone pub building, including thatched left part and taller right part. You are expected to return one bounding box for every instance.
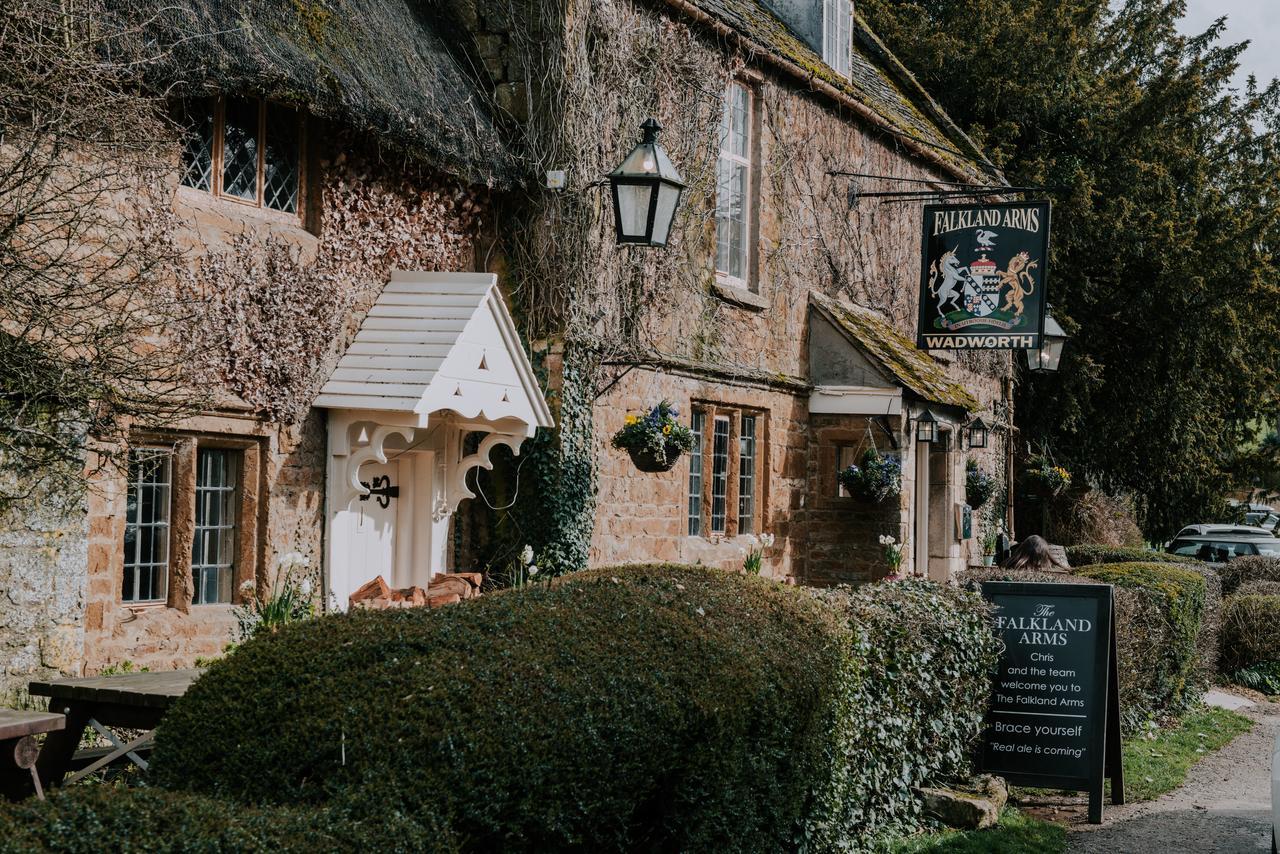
[0,0,1011,688]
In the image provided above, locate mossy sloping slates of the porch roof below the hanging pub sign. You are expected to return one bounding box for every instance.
[809,293,982,412]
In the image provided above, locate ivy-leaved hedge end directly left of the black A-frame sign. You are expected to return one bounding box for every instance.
[814,580,1000,850]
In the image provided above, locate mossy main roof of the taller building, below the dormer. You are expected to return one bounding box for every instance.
[689,0,1002,181]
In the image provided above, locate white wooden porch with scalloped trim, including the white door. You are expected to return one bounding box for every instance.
[315,271,552,607]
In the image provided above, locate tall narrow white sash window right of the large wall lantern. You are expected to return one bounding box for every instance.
[716,82,753,288]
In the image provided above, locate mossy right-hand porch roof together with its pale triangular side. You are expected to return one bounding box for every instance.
[809,293,982,412]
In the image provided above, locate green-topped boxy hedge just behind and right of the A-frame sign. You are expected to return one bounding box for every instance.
[1076,563,1207,729]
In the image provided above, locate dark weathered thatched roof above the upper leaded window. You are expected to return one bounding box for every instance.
[106,0,516,186]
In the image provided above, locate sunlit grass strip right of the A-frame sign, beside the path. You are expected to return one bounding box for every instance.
[1124,707,1253,802]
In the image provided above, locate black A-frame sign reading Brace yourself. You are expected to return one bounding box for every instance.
[982,581,1124,825]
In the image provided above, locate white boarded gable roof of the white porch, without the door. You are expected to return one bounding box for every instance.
[315,271,553,435]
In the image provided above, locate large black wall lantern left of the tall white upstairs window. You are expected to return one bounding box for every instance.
[609,119,685,246]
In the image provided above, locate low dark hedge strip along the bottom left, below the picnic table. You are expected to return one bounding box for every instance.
[0,786,458,854]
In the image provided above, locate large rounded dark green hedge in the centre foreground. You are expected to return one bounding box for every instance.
[152,566,859,851]
